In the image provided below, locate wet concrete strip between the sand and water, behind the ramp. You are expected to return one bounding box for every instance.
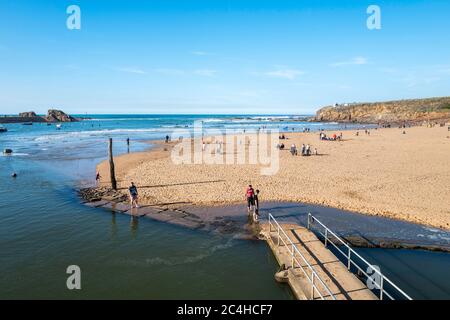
[82,200,450,252]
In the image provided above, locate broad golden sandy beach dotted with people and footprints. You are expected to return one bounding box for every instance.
[98,127,450,230]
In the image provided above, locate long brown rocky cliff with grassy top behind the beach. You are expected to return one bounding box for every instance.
[315,97,450,123]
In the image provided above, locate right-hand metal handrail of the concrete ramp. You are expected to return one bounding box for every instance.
[308,213,412,300]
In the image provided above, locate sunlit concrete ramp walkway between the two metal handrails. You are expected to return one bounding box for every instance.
[263,223,378,300]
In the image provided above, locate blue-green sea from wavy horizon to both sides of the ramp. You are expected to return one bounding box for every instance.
[0,114,450,300]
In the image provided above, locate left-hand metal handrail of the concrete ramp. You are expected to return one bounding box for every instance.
[269,213,336,300]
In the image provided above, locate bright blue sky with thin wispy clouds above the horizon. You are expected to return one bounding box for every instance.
[0,0,450,114]
